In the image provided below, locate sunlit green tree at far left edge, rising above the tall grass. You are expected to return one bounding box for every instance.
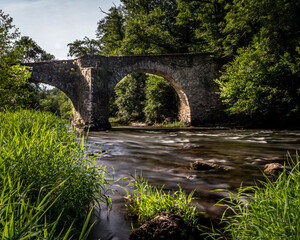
[0,10,30,110]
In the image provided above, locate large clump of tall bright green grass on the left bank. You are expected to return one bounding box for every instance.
[0,110,109,239]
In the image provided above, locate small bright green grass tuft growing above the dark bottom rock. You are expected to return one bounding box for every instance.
[127,173,200,227]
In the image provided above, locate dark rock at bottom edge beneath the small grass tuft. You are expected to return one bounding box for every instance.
[129,211,188,240]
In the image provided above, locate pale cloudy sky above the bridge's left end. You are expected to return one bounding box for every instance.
[0,0,120,60]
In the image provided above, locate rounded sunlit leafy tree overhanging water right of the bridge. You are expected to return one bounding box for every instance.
[217,44,300,118]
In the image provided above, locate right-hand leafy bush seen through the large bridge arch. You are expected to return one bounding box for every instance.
[144,75,178,122]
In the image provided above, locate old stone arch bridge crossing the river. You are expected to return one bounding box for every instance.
[24,54,223,131]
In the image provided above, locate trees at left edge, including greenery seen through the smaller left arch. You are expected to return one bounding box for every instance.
[0,10,72,119]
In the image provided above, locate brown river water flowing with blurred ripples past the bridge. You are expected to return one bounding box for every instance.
[89,128,300,240]
